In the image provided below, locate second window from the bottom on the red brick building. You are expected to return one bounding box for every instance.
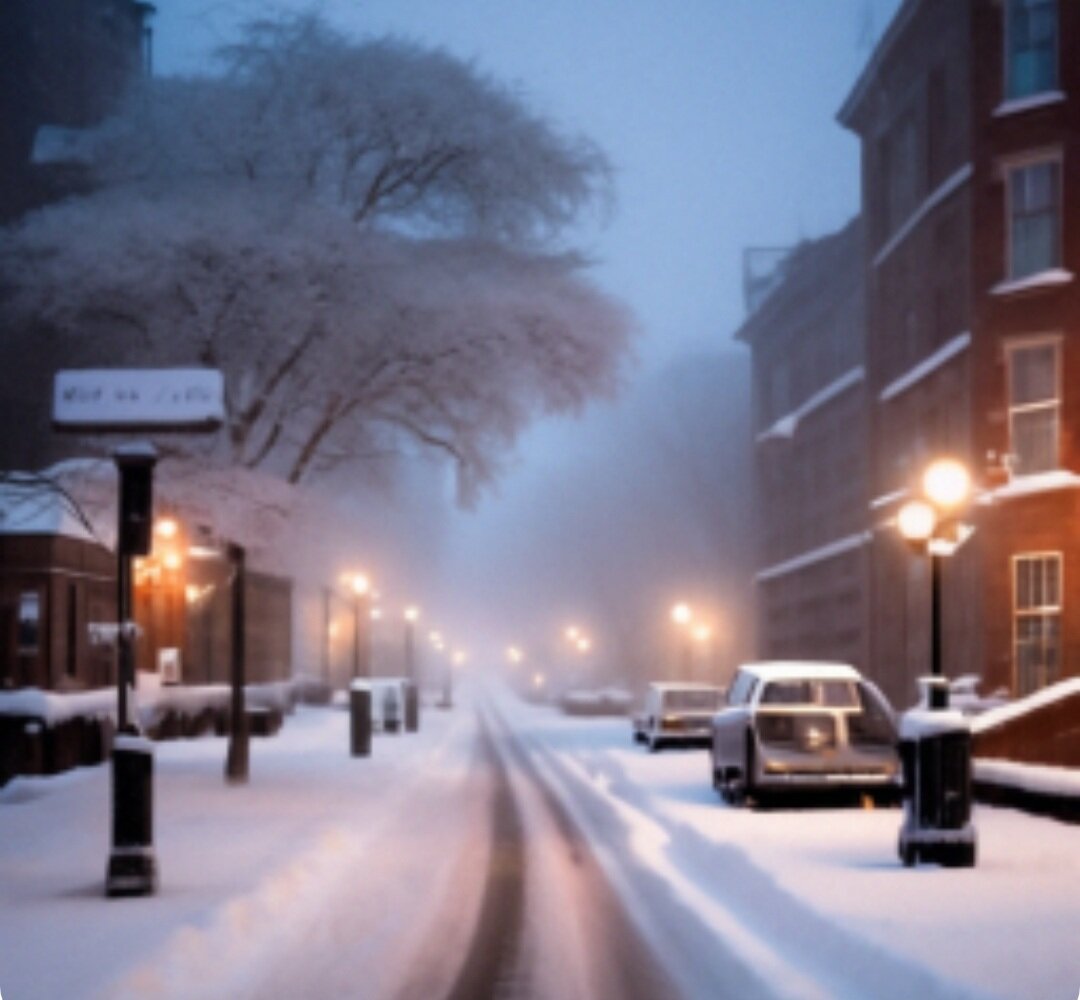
[1009,340,1061,475]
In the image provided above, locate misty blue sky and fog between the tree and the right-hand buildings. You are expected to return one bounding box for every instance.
[12,0,896,681]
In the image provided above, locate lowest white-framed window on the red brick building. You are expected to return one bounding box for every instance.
[1013,553,1063,697]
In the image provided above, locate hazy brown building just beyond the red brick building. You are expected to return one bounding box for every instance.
[735,219,867,666]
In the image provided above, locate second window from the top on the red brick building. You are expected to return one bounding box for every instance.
[1009,159,1062,280]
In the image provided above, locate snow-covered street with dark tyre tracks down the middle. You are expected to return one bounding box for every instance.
[0,689,1080,1000]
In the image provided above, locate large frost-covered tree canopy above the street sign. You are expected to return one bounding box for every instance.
[0,16,631,498]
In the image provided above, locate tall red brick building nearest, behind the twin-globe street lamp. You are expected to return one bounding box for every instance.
[839,0,1080,704]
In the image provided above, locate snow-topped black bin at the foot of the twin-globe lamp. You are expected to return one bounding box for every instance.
[897,678,976,867]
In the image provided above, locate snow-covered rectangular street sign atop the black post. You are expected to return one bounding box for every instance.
[53,368,225,432]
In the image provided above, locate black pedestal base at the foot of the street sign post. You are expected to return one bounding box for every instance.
[105,733,158,896]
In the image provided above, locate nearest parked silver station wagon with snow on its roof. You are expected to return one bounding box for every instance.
[711,662,900,802]
